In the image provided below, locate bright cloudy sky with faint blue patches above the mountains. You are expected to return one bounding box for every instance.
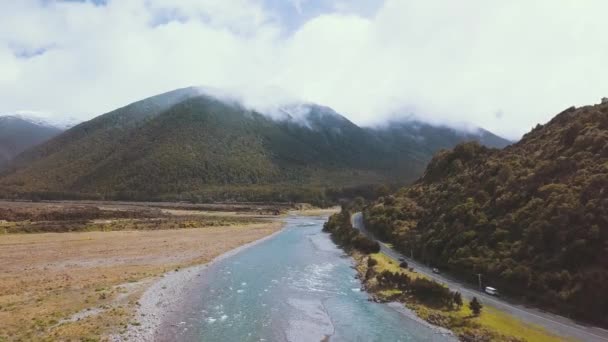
[0,0,608,139]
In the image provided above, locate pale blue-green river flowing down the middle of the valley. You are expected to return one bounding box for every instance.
[161,216,449,342]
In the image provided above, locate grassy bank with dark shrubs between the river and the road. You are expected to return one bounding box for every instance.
[324,209,563,342]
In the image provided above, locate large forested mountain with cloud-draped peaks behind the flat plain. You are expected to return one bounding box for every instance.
[0,88,508,202]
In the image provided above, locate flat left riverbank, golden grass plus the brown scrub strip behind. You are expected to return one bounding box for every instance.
[0,202,282,341]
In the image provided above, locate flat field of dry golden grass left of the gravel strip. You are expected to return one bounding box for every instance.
[0,222,281,341]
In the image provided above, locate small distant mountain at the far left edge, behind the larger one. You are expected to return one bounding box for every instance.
[0,115,62,168]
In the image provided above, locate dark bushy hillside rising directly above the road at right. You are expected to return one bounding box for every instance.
[364,103,608,325]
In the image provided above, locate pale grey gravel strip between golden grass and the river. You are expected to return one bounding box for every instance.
[115,229,282,342]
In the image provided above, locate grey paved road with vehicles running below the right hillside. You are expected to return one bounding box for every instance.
[352,213,608,342]
